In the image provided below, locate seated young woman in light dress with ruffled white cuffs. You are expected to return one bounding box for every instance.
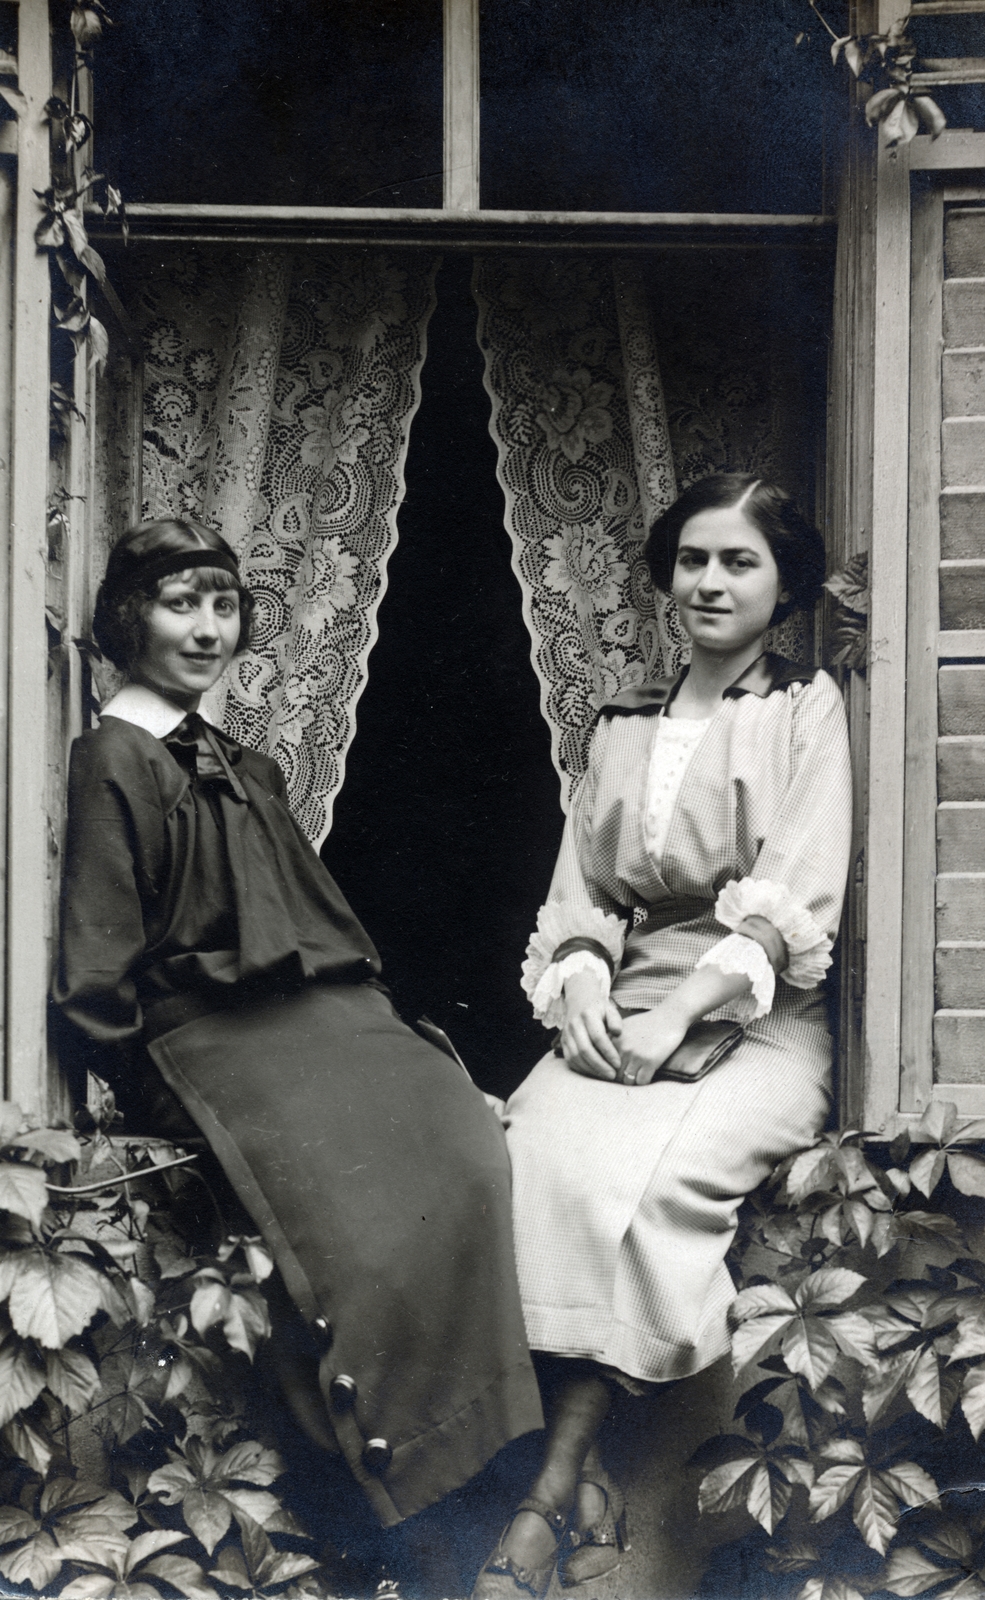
[473,474,851,1600]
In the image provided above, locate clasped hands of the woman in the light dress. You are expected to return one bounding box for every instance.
[561,973,694,1086]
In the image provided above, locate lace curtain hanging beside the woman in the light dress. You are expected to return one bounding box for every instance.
[473,264,688,805]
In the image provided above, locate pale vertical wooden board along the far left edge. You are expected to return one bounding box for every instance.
[6,0,51,1112]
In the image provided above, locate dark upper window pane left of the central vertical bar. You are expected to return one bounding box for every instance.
[94,0,441,206]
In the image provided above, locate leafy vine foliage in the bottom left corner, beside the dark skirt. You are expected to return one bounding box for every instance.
[0,1102,326,1600]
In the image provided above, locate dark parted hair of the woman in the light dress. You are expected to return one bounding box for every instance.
[644,472,825,624]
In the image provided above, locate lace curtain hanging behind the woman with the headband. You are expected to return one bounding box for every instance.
[99,251,438,845]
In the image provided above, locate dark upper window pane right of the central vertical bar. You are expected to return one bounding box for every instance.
[481,0,847,213]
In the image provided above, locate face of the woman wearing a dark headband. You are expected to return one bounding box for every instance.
[130,571,240,710]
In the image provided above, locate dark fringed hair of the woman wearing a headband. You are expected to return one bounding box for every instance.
[93,517,254,672]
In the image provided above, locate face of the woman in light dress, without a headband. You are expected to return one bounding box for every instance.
[673,506,787,654]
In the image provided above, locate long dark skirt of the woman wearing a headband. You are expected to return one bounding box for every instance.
[149,986,544,1525]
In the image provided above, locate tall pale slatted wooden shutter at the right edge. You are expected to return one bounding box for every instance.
[900,186,985,1114]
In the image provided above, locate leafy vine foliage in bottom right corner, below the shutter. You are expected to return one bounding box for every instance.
[696,1102,985,1600]
